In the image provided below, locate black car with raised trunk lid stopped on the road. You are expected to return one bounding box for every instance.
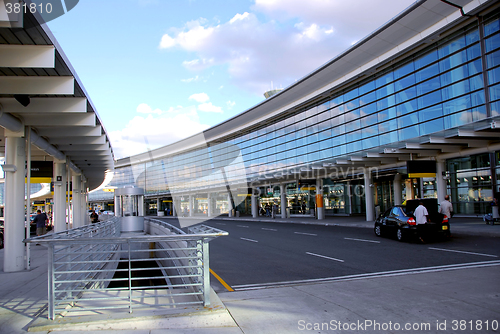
[374,198,451,241]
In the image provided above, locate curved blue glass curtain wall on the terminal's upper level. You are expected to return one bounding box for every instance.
[90,14,500,201]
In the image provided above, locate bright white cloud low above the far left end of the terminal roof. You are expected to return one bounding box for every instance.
[109,106,209,159]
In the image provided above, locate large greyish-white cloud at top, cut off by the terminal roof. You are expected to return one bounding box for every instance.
[160,0,414,95]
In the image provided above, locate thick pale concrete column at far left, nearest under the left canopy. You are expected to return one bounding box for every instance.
[3,137,26,272]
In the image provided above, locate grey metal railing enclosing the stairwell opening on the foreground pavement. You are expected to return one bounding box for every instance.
[24,217,228,319]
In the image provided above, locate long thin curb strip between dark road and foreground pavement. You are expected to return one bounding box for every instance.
[233,260,500,291]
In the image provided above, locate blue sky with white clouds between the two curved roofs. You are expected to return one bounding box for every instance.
[48,0,414,159]
